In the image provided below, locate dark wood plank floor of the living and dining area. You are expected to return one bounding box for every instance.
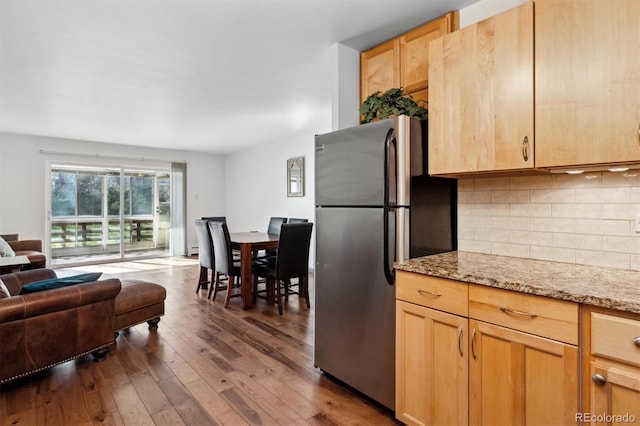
[0,258,396,425]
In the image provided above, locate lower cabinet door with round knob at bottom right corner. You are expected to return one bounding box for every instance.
[582,362,640,424]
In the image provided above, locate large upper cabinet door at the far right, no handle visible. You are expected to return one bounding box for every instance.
[535,0,640,167]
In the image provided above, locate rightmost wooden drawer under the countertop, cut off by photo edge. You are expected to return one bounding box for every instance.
[591,312,640,366]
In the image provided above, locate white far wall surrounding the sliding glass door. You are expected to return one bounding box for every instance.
[0,133,226,255]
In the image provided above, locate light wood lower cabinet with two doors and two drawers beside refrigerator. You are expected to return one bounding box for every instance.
[396,271,580,426]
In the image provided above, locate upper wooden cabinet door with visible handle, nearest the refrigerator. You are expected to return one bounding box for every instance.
[429,3,534,174]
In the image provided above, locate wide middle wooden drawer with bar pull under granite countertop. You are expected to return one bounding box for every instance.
[469,285,578,345]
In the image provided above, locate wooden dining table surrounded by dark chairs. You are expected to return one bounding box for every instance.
[229,231,280,309]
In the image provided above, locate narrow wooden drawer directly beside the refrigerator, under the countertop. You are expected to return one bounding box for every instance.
[396,271,469,317]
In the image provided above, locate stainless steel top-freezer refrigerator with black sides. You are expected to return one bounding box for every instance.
[314,116,457,410]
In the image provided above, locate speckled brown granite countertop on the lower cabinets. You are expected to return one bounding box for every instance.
[395,251,640,313]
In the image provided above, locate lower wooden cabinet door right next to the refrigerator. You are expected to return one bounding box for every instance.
[396,301,468,425]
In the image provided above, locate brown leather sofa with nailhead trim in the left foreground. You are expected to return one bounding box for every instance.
[0,269,121,384]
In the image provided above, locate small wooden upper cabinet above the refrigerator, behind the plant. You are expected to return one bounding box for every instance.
[360,12,458,102]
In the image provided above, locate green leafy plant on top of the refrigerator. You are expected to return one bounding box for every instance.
[360,87,428,124]
